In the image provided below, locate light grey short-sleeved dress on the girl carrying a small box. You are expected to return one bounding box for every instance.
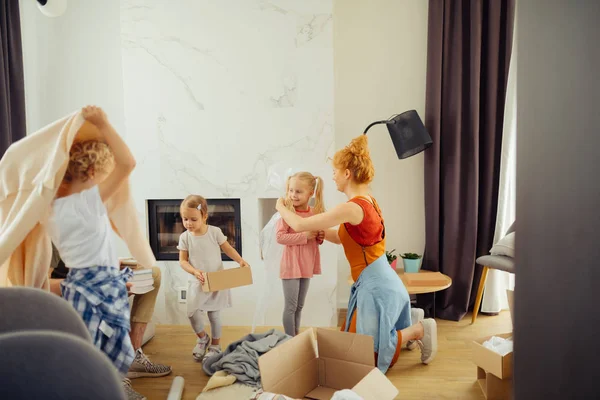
[177,225,231,317]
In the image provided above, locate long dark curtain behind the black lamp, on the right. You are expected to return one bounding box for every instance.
[419,0,515,321]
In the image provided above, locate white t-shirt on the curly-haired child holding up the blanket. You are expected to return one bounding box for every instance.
[48,185,119,268]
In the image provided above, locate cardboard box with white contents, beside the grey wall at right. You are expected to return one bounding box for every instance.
[473,333,513,400]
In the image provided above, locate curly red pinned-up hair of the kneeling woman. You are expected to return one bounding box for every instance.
[333,135,375,183]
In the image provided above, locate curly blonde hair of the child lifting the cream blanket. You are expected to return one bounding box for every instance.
[64,140,115,183]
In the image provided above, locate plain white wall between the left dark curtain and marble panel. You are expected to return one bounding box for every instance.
[19,0,124,133]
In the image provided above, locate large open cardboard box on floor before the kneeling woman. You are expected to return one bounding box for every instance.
[258,328,398,400]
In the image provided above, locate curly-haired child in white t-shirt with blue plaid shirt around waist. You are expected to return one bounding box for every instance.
[48,106,135,382]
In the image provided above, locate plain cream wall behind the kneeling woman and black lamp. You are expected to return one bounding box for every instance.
[333,0,428,305]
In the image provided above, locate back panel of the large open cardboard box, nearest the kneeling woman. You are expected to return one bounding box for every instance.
[317,328,375,367]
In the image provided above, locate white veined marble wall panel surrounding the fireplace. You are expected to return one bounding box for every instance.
[121,0,337,326]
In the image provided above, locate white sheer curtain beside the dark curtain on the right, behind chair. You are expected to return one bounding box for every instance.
[481,15,518,313]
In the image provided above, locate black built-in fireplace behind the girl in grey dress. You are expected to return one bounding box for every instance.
[148,199,242,261]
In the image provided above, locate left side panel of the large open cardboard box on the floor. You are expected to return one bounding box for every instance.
[258,329,319,398]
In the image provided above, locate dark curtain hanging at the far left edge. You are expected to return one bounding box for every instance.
[0,0,27,157]
